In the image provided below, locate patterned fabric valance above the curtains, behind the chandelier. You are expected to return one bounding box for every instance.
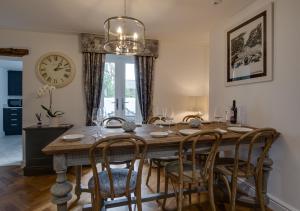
[80,33,158,58]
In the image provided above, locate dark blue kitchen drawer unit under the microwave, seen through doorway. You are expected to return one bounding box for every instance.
[3,108,22,135]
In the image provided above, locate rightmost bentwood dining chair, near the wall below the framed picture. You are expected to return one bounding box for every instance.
[215,128,277,211]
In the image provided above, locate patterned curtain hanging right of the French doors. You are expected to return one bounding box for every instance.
[135,56,155,123]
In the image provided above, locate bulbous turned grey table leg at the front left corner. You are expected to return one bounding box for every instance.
[50,154,72,211]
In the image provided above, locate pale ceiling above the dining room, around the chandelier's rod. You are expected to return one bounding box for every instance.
[0,0,255,39]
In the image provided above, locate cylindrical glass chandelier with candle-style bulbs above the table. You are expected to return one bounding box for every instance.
[104,0,145,55]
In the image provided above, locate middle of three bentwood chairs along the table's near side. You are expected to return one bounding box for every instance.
[163,130,222,211]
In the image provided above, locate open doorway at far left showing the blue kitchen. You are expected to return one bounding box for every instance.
[0,56,23,166]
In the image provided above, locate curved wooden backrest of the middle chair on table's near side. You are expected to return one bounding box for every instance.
[179,130,222,182]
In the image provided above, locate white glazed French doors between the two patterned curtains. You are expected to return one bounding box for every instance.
[101,54,141,122]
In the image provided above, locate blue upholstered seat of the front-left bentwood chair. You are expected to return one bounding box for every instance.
[88,168,137,197]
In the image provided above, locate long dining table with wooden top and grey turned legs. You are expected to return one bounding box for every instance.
[43,122,273,211]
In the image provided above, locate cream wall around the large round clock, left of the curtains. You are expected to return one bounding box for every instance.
[0,30,85,126]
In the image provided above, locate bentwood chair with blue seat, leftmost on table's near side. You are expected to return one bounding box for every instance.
[88,135,147,211]
